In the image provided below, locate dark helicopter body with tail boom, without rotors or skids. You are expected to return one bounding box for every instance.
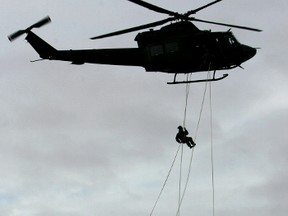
[26,21,256,73]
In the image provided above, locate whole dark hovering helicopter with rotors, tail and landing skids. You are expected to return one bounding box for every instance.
[8,0,261,84]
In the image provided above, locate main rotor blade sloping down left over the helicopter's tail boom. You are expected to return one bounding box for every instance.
[90,18,174,40]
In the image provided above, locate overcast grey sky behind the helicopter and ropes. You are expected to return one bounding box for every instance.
[0,0,288,216]
